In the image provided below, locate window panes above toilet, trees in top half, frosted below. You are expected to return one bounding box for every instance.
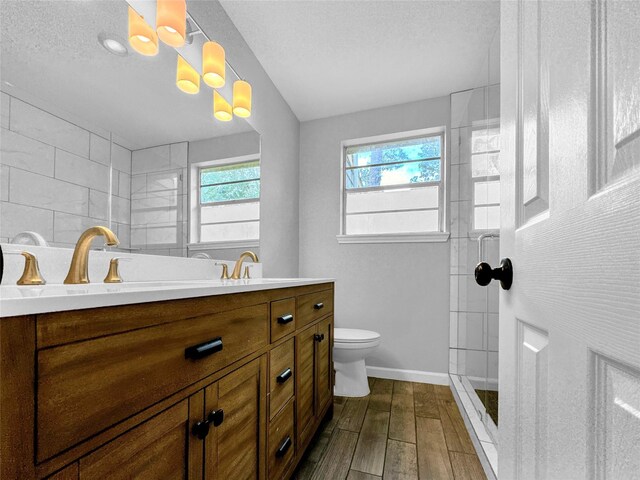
[342,133,444,235]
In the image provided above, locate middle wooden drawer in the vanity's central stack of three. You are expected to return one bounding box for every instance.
[269,338,295,419]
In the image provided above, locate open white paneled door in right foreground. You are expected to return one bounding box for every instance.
[500,0,640,480]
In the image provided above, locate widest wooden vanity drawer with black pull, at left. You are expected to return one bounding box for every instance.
[36,303,269,460]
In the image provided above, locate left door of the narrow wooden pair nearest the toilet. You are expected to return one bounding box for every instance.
[296,325,316,448]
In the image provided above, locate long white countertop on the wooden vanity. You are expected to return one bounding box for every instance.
[0,278,334,317]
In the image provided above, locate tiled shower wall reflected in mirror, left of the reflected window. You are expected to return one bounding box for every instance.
[131,142,188,256]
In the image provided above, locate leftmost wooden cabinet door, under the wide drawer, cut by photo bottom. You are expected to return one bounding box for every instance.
[79,400,189,480]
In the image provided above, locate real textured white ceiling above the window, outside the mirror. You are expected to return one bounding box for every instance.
[221,0,500,121]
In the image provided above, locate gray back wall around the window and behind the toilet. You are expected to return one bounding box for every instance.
[300,96,450,373]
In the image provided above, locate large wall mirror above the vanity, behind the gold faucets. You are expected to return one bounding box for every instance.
[0,0,260,258]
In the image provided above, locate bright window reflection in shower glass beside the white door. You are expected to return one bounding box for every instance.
[471,127,500,230]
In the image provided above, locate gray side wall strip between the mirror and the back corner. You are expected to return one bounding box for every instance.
[189,1,300,277]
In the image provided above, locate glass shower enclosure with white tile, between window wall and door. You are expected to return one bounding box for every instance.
[449,26,500,472]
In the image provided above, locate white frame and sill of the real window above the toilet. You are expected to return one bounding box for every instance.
[337,126,449,243]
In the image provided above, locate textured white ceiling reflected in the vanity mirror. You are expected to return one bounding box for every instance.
[0,0,252,148]
